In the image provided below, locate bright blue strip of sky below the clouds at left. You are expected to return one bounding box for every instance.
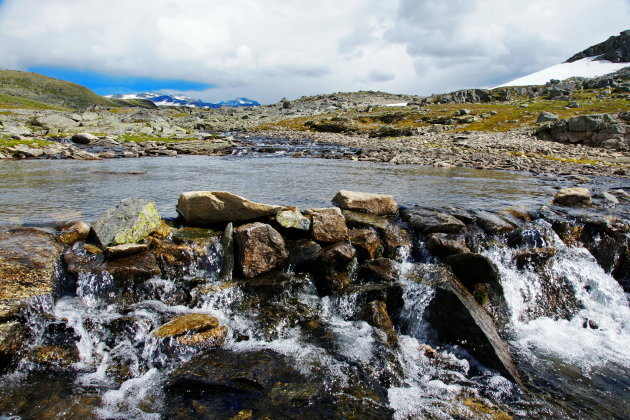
[27,65,214,95]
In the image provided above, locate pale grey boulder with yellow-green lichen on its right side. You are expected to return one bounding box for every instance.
[94,198,162,247]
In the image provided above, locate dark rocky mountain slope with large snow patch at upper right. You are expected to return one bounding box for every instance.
[499,30,630,87]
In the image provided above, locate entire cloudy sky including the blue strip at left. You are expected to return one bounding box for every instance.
[0,0,630,103]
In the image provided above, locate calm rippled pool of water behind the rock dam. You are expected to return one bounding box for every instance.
[0,156,552,224]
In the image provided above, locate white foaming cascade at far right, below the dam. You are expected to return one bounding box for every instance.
[485,225,630,374]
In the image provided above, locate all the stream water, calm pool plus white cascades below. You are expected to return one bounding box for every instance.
[0,150,630,419]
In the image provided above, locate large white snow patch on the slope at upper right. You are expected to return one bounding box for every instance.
[497,57,630,87]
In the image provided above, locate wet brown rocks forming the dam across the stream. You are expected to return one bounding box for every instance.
[0,189,630,392]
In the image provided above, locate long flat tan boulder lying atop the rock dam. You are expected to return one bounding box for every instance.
[177,191,285,226]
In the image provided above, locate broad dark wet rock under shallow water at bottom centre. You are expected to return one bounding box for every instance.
[164,349,391,419]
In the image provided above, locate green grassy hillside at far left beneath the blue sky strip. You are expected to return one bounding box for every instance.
[0,70,155,109]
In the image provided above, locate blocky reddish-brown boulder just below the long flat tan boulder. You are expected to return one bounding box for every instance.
[234,222,288,278]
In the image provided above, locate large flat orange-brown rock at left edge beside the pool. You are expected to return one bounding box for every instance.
[0,227,61,320]
